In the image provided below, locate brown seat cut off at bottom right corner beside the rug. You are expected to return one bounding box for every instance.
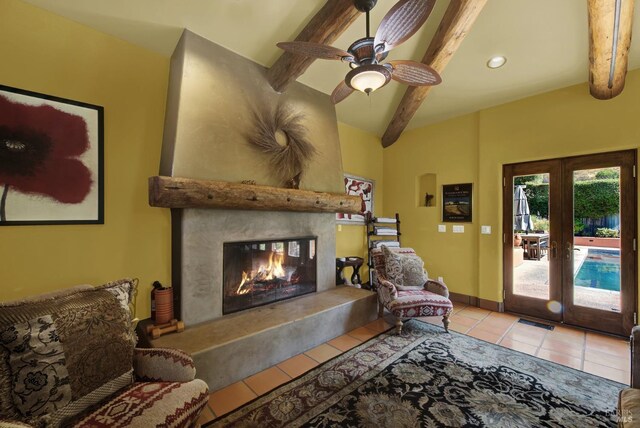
[618,326,640,428]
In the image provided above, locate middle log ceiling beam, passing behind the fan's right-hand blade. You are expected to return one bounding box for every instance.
[382,0,487,147]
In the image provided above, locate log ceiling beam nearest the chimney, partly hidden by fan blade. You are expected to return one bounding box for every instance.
[267,0,361,92]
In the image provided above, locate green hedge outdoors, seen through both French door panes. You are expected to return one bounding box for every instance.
[524,179,620,218]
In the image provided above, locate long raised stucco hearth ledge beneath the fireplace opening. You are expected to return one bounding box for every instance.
[150,286,378,390]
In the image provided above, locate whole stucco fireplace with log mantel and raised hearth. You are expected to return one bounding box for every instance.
[149,30,377,390]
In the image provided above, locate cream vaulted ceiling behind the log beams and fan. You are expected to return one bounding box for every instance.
[25,0,640,143]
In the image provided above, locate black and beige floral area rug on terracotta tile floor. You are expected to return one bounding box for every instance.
[207,320,624,428]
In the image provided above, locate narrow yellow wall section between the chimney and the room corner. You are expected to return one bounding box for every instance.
[336,123,384,282]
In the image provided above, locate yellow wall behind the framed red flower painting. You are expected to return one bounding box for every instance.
[0,0,170,317]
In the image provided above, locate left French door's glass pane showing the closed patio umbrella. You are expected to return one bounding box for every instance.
[513,174,549,300]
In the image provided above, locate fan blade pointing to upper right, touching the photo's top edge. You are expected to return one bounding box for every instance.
[374,0,436,52]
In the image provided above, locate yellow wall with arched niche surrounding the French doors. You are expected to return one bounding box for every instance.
[384,70,640,301]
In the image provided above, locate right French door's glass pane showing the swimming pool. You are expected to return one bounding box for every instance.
[564,167,624,312]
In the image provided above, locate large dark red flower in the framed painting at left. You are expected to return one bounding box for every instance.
[0,96,93,221]
